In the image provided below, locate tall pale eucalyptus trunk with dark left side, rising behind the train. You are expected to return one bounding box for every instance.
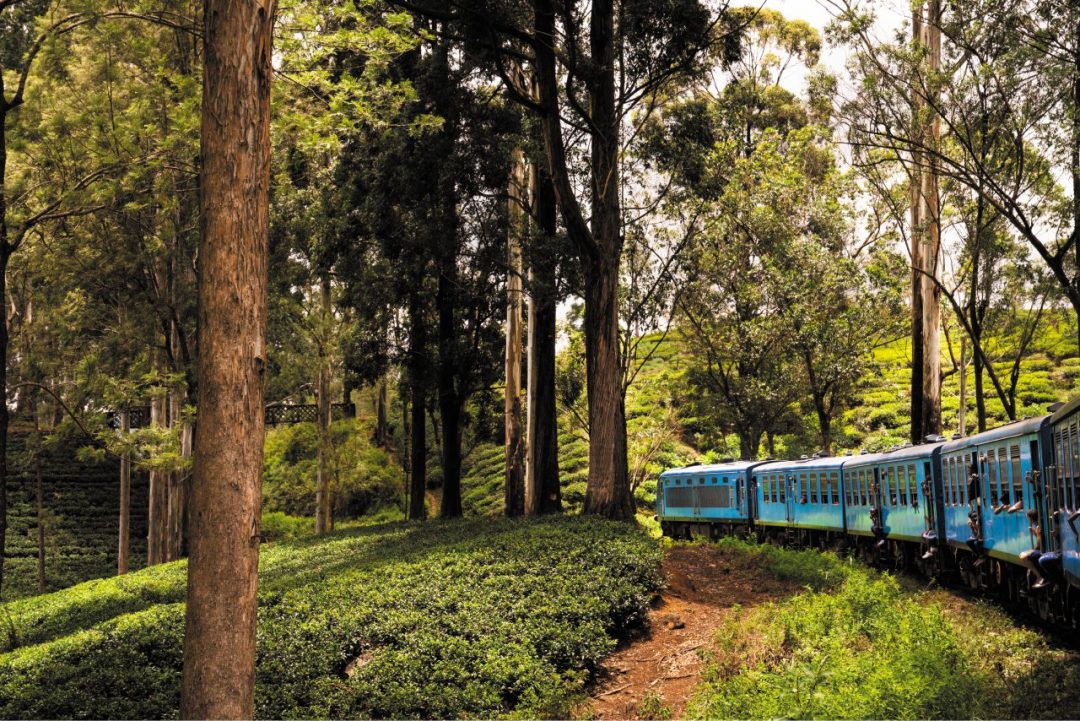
[910,0,942,443]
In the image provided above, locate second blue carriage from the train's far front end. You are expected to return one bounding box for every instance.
[754,457,843,532]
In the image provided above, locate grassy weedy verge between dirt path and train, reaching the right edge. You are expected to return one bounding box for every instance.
[688,540,1080,719]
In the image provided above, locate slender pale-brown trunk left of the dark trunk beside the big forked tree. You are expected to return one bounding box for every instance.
[503,149,528,516]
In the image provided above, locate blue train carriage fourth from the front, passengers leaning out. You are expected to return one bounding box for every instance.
[940,416,1050,564]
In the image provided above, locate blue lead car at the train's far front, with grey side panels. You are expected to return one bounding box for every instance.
[657,462,760,526]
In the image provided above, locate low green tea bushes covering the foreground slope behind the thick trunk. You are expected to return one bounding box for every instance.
[0,517,660,718]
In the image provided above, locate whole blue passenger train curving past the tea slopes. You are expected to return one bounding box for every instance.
[657,398,1080,627]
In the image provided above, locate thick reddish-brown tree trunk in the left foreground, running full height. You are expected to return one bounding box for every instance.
[180,0,275,719]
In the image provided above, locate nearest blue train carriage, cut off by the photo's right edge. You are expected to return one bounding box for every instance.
[1040,398,1080,587]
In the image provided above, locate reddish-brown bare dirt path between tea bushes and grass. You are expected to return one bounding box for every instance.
[591,545,799,719]
